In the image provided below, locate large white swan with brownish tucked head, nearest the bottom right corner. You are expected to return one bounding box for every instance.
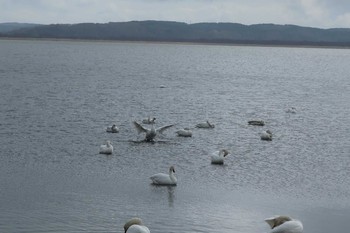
[265,216,303,233]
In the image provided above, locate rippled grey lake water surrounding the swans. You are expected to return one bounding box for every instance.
[0,40,350,233]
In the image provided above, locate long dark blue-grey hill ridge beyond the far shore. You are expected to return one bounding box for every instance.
[0,21,350,46]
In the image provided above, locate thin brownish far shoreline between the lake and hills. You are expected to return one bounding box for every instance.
[0,37,350,49]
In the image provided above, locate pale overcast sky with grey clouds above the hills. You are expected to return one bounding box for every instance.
[0,0,350,28]
